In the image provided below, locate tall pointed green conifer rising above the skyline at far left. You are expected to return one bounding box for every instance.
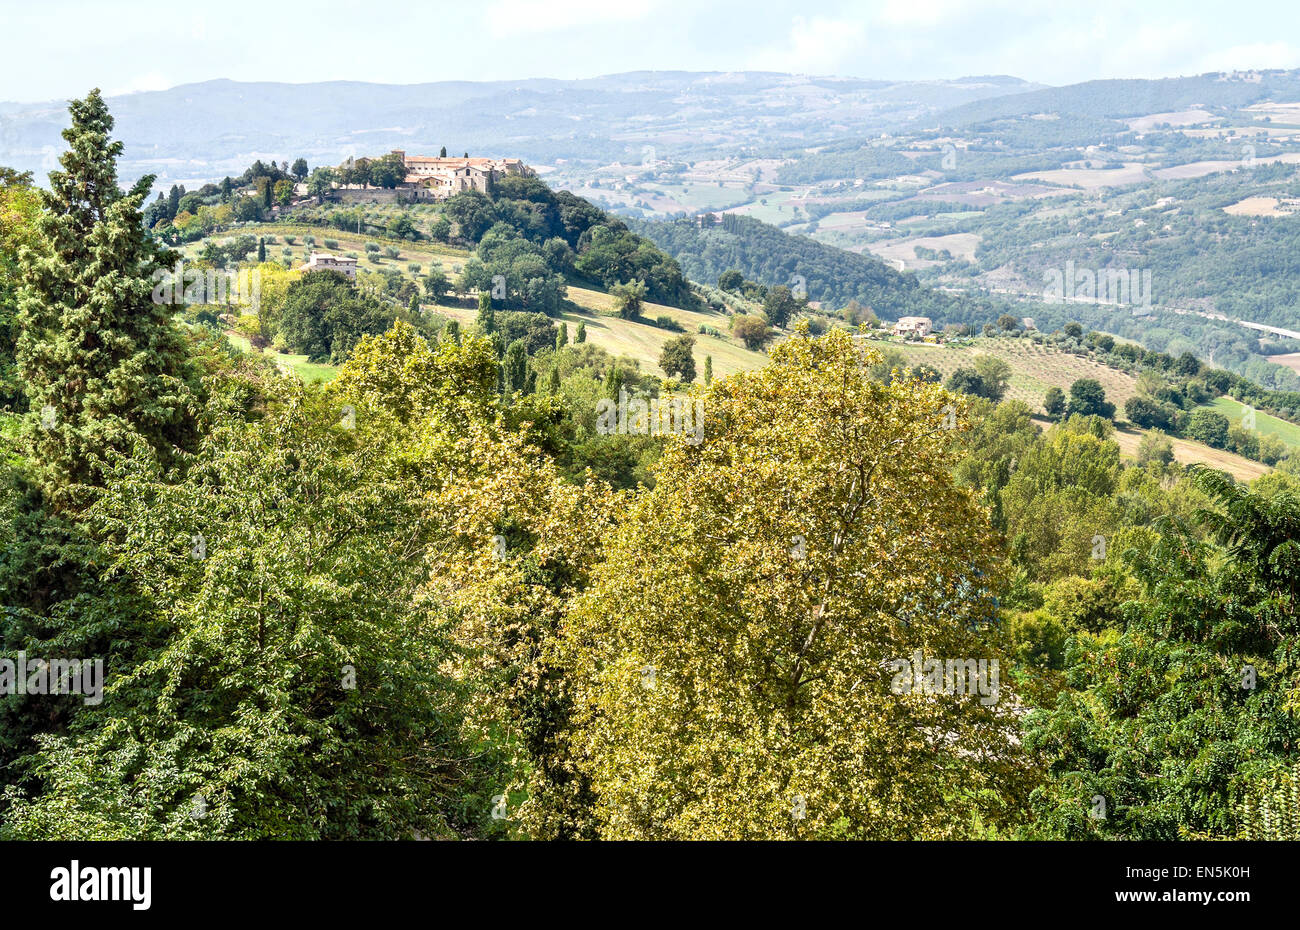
[17,90,195,509]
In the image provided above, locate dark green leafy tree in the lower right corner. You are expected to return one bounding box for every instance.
[1027,470,1300,839]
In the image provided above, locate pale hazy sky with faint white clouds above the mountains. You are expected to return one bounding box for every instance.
[0,0,1300,100]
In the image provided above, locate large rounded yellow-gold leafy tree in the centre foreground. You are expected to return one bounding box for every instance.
[562,332,1015,838]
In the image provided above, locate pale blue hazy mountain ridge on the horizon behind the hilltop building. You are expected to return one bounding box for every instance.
[0,72,1043,187]
